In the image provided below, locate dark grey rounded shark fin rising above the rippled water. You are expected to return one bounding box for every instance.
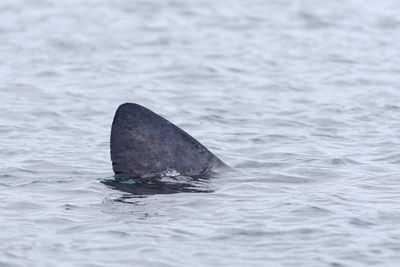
[110,103,229,179]
